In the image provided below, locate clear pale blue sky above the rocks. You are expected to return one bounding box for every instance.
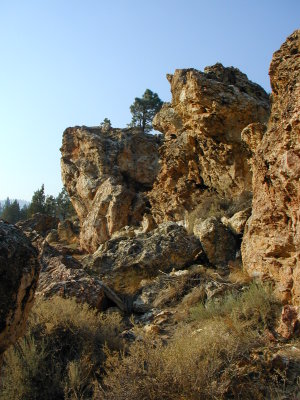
[0,0,300,200]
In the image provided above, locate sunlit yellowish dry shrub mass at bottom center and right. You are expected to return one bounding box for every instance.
[98,284,286,400]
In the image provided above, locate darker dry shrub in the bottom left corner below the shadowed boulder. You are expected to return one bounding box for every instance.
[0,297,122,400]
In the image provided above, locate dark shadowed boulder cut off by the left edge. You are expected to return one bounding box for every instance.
[0,221,40,357]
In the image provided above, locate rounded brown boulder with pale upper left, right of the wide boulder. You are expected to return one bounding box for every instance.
[194,217,237,266]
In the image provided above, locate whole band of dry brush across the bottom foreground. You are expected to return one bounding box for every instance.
[0,283,300,400]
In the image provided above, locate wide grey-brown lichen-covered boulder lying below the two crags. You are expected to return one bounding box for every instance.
[90,222,204,295]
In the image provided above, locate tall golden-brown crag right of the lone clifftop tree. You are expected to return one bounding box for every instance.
[149,64,269,223]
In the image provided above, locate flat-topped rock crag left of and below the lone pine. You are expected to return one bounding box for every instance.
[61,127,159,252]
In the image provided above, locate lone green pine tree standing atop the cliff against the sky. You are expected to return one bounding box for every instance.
[129,89,163,133]
